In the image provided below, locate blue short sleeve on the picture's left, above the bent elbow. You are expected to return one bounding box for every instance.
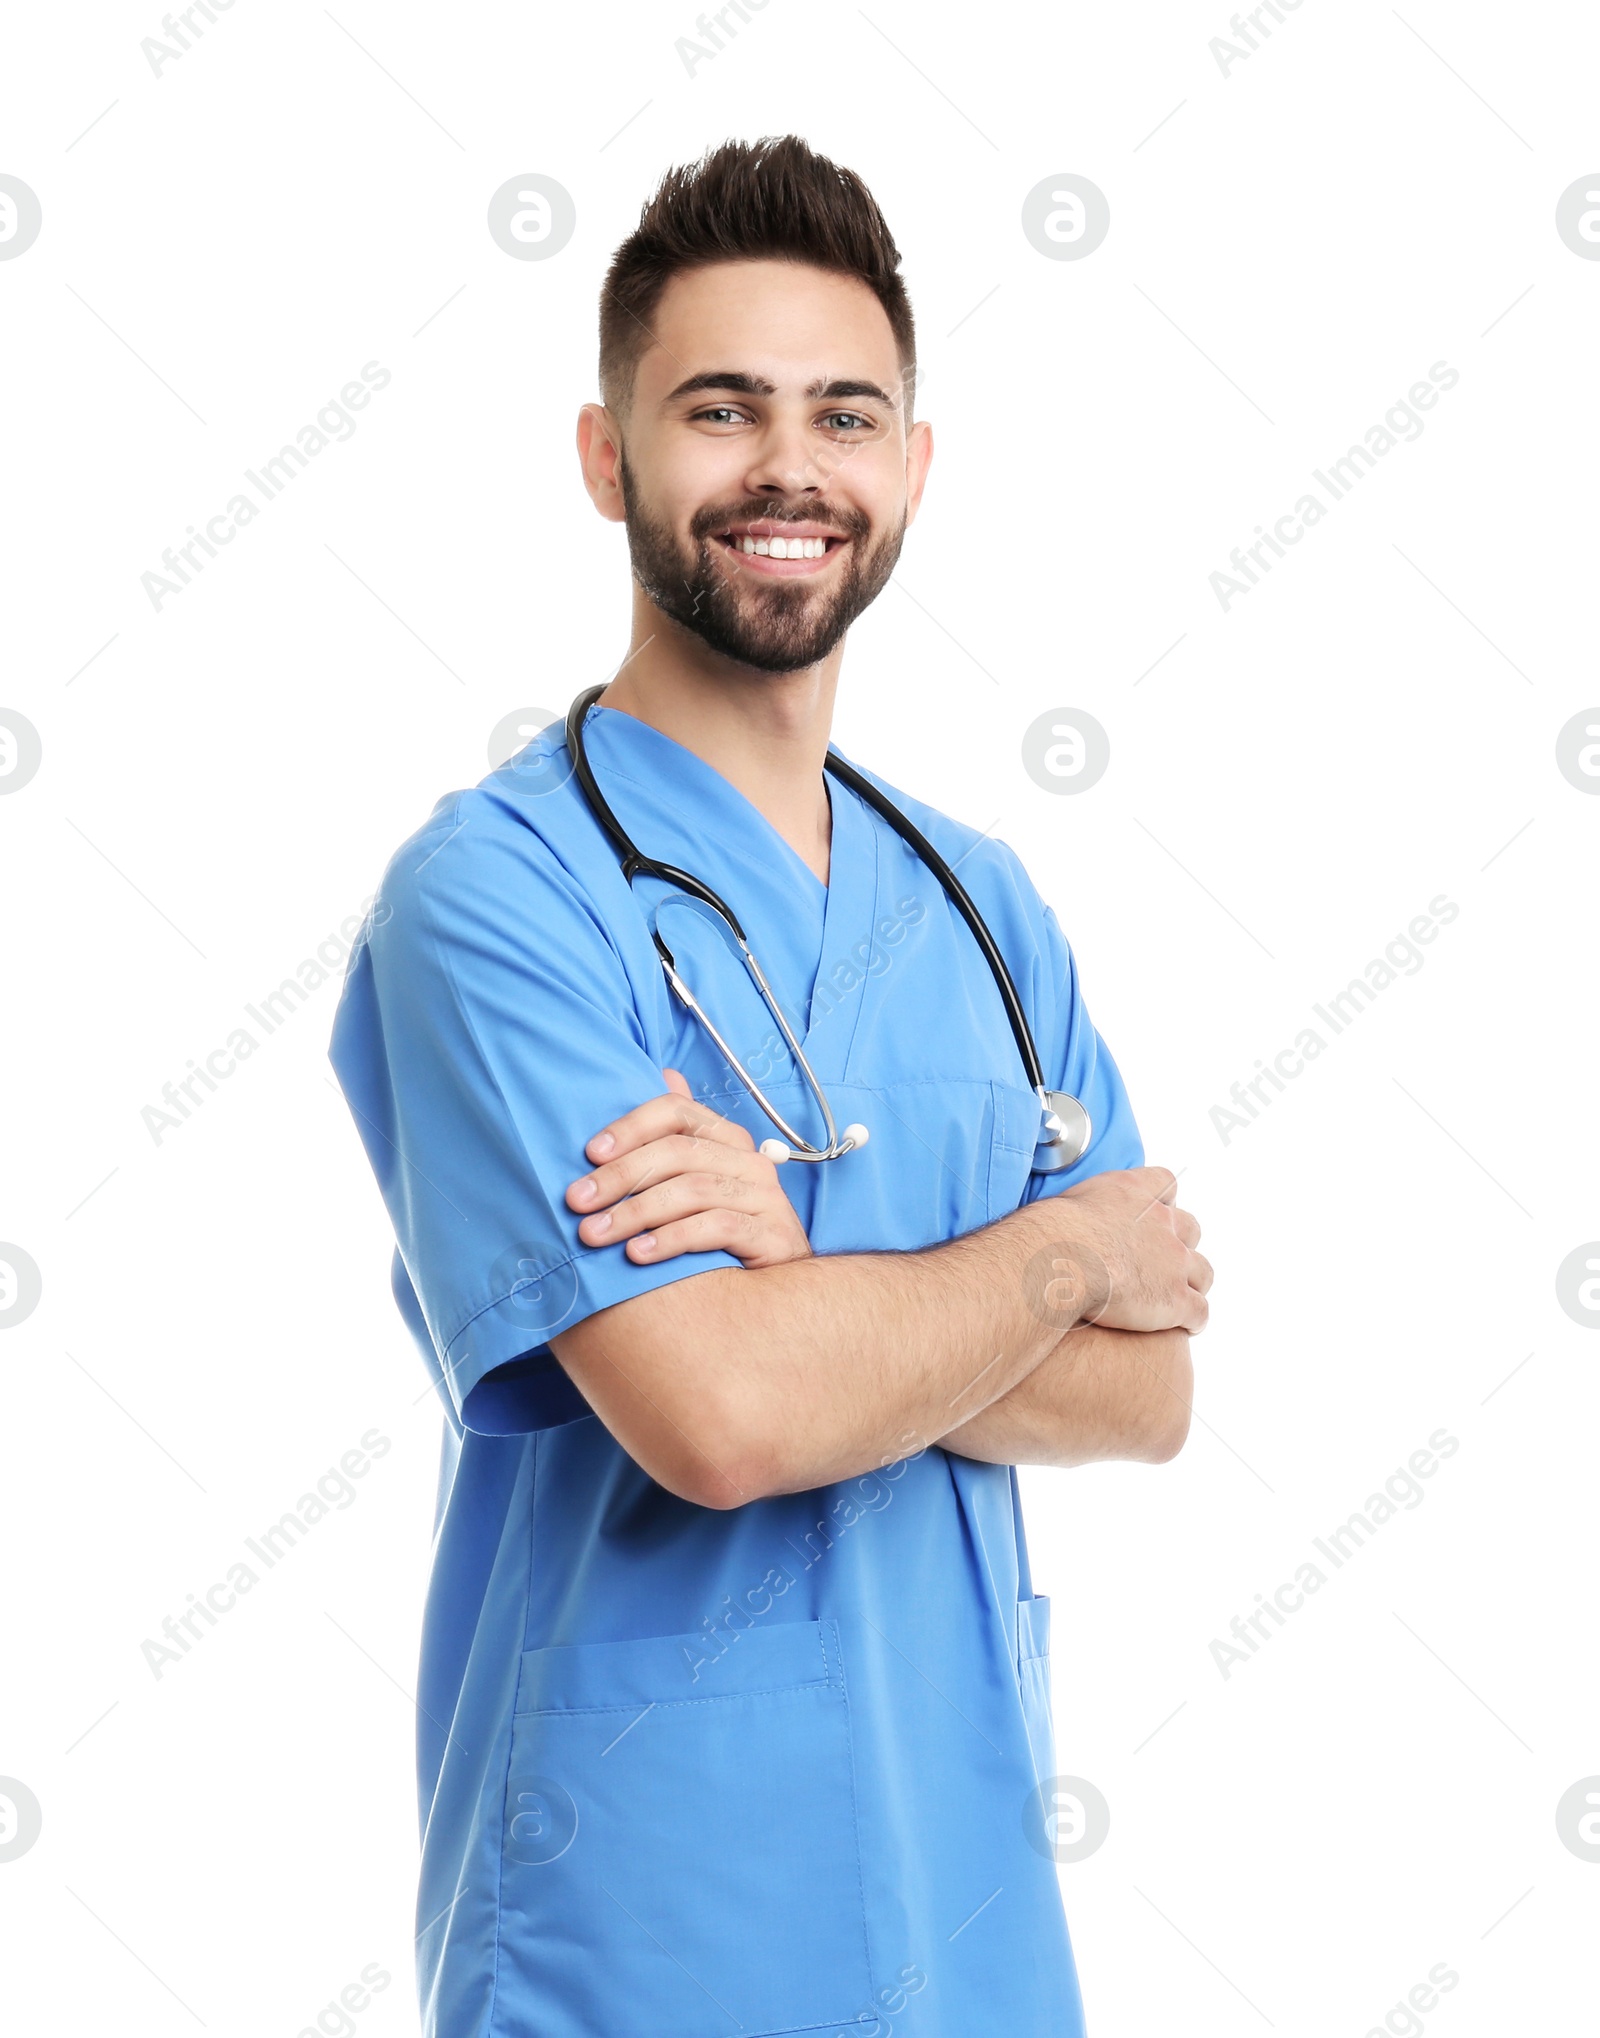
[328,793,738,1435]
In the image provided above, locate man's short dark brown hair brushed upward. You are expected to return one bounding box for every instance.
[599,135,917,418]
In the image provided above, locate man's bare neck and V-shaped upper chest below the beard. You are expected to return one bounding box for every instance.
[601,587,844,884]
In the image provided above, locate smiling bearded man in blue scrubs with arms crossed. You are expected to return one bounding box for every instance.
[332,137,1211,2038]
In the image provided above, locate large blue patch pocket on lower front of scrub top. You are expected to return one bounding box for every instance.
[493,1620,870,2038]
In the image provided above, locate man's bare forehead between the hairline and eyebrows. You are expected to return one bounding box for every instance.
[636,261,899,404]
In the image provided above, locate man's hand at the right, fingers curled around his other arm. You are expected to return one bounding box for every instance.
[1029,1168,1213,1335]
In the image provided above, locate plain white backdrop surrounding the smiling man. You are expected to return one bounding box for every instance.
[0,0,1600,2038]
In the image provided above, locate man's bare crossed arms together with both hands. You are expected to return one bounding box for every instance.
[552,1070,1211,1508]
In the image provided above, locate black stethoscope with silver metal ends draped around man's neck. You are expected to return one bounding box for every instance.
[567,685,1092,1174]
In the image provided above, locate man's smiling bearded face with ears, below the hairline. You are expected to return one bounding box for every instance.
[589,261,931,673]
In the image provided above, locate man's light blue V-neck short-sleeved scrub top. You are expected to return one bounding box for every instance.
[330,707,1143,2038]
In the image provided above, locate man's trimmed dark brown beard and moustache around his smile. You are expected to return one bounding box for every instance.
[618,467,905,673]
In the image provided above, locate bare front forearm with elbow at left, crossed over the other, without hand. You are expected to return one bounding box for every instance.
[552,1204,1097,1506]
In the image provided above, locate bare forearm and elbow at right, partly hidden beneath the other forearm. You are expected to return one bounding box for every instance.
[938,1323,1194,1465]
